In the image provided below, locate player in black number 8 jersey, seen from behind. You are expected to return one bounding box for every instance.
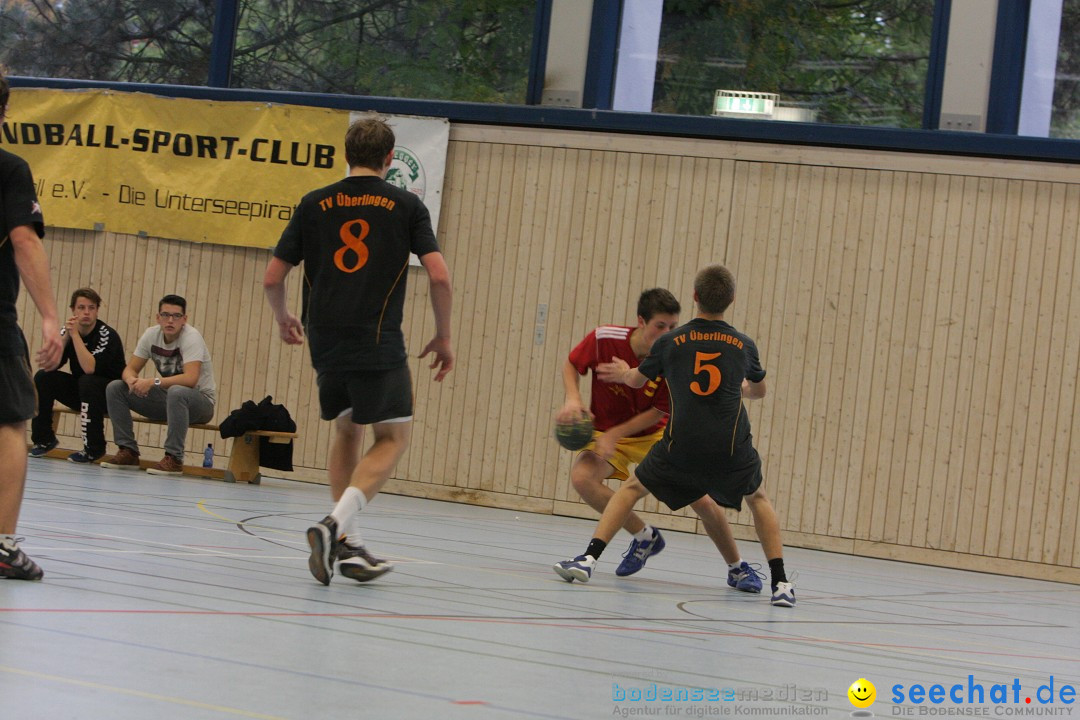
[270,116,454,584]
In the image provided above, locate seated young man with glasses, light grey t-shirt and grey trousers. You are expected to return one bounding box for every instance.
[102,295,215,475]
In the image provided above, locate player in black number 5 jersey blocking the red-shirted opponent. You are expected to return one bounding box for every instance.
[555,266,795,608]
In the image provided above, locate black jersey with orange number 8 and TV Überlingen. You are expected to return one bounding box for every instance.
[274,176,438,372]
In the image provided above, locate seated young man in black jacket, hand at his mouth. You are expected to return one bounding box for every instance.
[30,287,124,463]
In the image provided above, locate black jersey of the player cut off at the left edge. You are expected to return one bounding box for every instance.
[0,150,45,355]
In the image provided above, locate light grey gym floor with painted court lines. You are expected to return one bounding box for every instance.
[0,460,1080,720]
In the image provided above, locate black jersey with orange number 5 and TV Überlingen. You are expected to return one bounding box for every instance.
[637,317,765,473]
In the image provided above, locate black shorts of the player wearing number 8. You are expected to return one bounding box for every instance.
[319,365,413,425]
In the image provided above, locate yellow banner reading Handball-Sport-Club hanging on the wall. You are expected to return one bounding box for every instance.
[0,89,349,247]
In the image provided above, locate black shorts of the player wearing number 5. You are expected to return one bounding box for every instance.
[635,441,761,511]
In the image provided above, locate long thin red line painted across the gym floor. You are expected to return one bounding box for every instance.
[0,608,1080,663]
